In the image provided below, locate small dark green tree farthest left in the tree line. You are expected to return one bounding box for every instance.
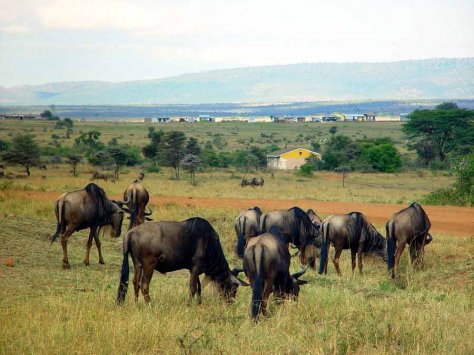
[4,134,40,176]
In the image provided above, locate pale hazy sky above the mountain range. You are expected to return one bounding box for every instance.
[0,0,474,86]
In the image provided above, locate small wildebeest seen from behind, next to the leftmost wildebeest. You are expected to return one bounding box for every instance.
[121,180,153,230]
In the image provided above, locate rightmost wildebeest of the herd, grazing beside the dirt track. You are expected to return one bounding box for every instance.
[385,202,433,277]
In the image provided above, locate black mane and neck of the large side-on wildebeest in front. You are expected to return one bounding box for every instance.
[183,217,229,281]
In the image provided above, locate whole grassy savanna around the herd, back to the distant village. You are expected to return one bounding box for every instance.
[0,122,474,354]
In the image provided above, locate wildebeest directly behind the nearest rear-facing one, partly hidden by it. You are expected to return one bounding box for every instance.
[260,207,321,269]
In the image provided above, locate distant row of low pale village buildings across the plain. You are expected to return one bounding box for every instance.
[0,113,409,123]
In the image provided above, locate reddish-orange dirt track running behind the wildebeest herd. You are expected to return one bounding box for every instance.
[0,191,474,237]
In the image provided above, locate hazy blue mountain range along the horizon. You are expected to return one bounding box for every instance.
[0,58,474,105]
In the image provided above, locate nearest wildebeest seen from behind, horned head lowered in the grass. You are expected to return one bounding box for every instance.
[243,226,307,320]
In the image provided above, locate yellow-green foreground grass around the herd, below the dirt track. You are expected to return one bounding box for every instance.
[0,206,474,354]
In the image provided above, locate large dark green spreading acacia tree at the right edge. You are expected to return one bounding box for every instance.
[402,103,474,161]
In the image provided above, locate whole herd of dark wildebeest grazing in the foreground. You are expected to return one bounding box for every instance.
[51,175,432,320]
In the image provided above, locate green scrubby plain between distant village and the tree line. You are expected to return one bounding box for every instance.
[0,121,405,152]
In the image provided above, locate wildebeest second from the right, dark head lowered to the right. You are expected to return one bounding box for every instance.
[319,212,386,275]
